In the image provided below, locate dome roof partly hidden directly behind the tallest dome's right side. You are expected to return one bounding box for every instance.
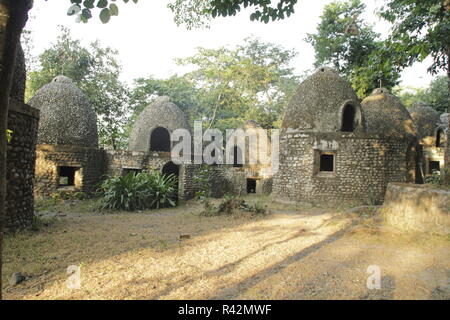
[361,88,416,138]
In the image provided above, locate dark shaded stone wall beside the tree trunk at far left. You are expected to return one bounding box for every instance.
[6,100,39,229]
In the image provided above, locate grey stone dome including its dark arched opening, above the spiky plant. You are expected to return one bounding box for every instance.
[128,97,190,152]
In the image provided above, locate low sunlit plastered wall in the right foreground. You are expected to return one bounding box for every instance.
[383,183,450,236]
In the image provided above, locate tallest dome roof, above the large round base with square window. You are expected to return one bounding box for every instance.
[281,67,364,132]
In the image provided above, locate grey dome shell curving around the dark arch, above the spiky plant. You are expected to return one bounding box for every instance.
[128,96,190,151]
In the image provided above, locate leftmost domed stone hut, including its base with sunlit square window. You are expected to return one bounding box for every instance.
[29,76,104,196]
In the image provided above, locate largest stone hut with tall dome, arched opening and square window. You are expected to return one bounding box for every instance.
[273,68,414,203]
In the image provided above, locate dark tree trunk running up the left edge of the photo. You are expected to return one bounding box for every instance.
[0,0,32,300]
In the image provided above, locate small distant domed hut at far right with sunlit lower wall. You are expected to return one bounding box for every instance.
[409,102,447,175]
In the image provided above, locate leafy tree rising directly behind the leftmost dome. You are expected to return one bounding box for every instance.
[26,28,128,150]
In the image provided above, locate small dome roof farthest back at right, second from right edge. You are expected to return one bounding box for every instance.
[408,102,440,139]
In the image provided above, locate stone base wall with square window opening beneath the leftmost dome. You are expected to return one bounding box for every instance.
[35,145,105,197]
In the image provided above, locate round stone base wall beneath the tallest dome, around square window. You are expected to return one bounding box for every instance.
[273,132,414,203]
